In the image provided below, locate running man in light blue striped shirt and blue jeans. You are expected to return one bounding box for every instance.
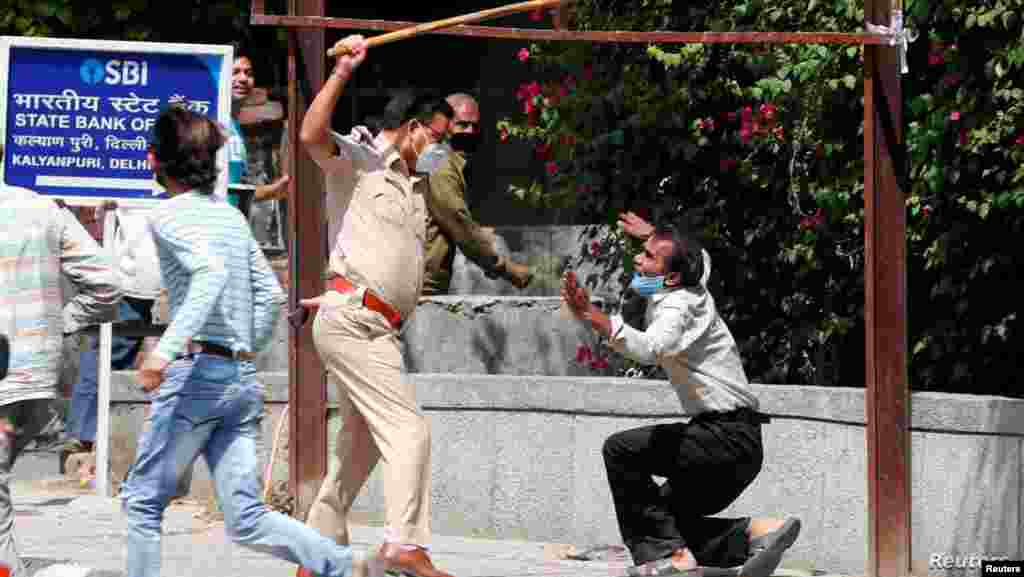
[122,107,366,577]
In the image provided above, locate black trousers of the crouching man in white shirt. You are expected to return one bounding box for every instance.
[603,409,768,567]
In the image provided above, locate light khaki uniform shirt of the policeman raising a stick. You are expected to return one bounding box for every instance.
[321,126,428,321]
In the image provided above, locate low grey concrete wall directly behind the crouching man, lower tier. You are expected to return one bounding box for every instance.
[112,373,1024,577]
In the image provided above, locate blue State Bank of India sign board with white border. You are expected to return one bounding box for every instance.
[0,37,232,205]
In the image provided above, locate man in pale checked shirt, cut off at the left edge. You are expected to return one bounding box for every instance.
[0,147,121,577]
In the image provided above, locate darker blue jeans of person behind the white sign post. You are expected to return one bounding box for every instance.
[68,297,154,443]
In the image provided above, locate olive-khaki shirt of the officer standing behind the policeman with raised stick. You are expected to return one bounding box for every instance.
[423,152,499,294]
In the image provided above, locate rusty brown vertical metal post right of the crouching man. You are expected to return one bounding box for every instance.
[864,0,911,577]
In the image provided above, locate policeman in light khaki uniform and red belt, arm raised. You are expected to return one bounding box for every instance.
[297,35,454,577]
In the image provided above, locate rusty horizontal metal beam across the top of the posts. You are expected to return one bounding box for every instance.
[250,12,893,45]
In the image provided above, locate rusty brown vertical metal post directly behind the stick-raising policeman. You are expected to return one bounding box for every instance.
[288,0,327,519]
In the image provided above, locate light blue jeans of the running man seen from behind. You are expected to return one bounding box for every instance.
[122,354,353,577]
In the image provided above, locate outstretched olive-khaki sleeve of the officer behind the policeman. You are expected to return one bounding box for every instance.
[427,157,500,272]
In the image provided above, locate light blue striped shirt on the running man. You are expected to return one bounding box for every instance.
[150,191,285,360]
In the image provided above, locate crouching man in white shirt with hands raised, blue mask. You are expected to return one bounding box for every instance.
[561,212,800,577]
